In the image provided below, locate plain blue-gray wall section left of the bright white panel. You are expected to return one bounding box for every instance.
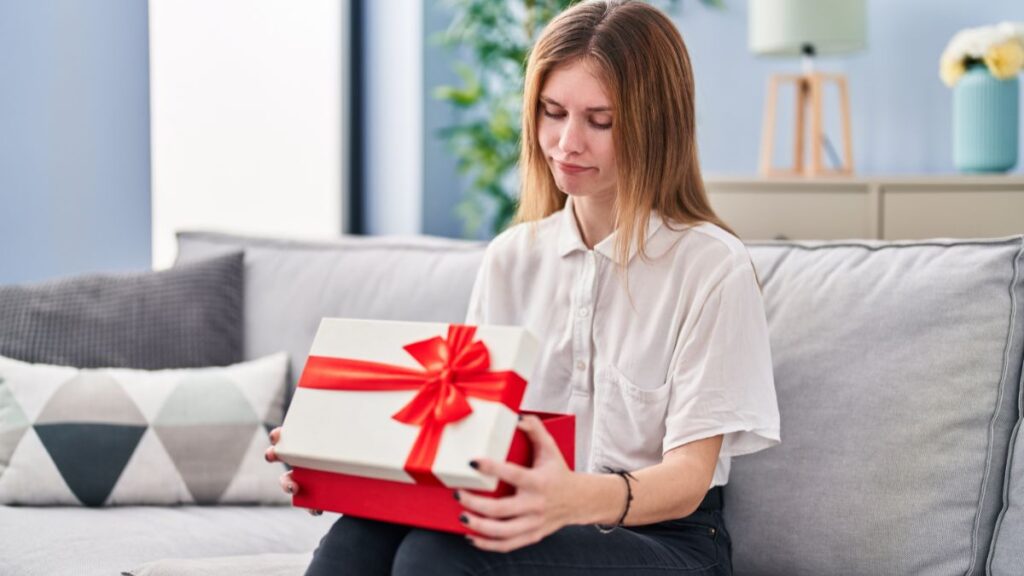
[0,0,151,284]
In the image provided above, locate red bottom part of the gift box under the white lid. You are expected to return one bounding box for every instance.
[292,412,575,534]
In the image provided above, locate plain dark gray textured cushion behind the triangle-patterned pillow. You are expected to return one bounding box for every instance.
[0,253,243,370]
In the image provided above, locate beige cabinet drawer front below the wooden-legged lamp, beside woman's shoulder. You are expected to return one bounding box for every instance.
[708,190,877,240]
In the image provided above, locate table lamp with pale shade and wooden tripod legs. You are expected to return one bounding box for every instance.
[749,0,867,176]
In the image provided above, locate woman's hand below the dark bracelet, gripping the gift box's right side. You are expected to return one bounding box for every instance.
[456,416,579,552]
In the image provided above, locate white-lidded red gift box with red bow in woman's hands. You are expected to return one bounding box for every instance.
[276,319,574,533]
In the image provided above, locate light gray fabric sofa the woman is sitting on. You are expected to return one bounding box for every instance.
[0,232,1024,576]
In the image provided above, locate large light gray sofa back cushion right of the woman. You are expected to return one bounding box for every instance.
[725,237,1024,576]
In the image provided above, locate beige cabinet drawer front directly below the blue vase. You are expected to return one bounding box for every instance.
[882,190,1024,240]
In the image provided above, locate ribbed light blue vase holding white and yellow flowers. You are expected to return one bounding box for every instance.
[953,65,1020,172]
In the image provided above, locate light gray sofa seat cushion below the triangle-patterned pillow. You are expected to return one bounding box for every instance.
[0,506,327,576]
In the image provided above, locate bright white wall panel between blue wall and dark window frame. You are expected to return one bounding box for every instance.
[150,0,348,269]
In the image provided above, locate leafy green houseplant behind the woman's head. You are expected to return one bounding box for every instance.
[434,0,723,234]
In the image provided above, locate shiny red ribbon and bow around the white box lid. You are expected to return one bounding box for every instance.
[299,324,526,486]
